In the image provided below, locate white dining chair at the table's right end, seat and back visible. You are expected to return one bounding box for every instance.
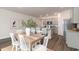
[33,37,49,51]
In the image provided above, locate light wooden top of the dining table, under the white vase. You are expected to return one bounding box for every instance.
[16,33,44,44]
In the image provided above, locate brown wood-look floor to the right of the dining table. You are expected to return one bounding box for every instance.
[48,35,78,51]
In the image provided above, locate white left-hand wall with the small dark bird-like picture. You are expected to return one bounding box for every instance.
[0,9,33,39]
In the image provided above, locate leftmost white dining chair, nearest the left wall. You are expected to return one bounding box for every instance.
[9,33,19,51]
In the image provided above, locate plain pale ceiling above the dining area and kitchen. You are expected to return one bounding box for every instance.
[1,7,71,17]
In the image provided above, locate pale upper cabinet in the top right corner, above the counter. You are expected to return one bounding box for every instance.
[72,7,79,23]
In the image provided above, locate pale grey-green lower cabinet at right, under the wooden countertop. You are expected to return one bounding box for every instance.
[66,30,79,49]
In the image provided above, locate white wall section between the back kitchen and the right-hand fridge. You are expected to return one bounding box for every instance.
[58,10,72,36]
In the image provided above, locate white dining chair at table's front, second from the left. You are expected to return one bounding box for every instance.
[18,34,28,51]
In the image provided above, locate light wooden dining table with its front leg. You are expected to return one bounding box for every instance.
[17,33,44,51]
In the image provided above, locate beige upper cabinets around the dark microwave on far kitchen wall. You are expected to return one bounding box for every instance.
[41,16,58,29]
